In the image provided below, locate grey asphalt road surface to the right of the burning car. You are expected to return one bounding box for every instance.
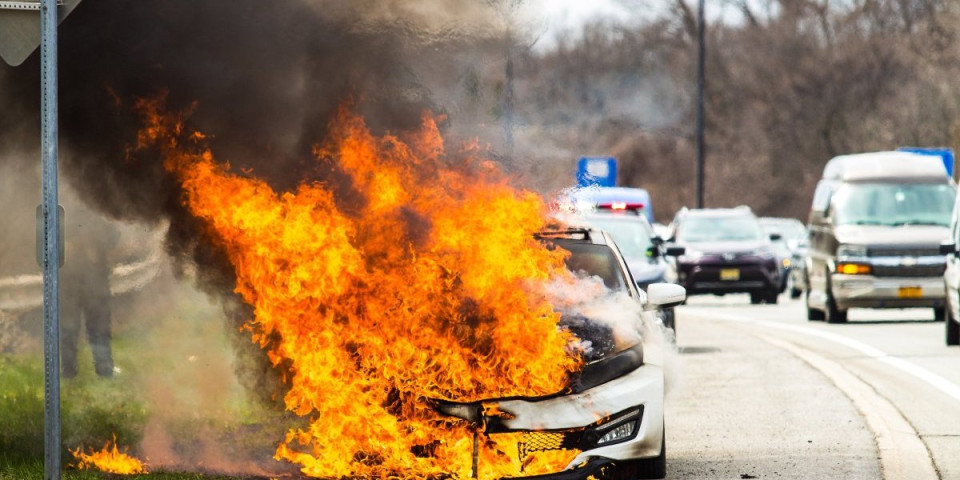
[666,295,960,480]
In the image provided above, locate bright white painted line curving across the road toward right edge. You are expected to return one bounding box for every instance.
[691,309,960,402]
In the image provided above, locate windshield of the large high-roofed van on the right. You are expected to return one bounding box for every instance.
[830,183,955,226]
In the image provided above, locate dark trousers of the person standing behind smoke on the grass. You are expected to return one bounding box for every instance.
[60,294,113,378]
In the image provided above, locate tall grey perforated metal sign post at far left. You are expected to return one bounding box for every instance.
[40,0,60,480]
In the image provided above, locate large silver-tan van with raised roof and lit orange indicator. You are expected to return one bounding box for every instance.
[806,152,956,323]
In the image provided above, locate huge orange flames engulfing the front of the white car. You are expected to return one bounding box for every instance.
[137,100,640,478]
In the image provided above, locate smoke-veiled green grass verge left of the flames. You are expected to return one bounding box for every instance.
[0,284,303,480]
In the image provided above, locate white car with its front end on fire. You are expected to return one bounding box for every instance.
[434,229,685,480]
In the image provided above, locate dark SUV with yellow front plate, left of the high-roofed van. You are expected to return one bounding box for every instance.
[672,207,781,304]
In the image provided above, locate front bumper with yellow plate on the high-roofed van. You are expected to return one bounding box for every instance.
[830,274,946,310]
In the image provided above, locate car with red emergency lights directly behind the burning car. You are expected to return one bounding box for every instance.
[579,208,684,329]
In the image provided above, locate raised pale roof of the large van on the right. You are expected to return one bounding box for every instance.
[823,151,947,181]
